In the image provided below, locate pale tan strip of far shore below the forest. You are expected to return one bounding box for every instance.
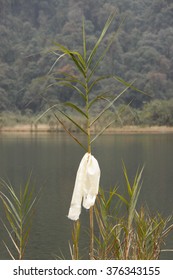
[0,124,173,134]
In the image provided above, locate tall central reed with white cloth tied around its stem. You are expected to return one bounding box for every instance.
[41,12,145,259]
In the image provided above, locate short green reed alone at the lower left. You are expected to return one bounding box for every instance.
[0,177,37,260]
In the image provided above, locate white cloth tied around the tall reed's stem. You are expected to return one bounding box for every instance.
[68,153,100,221]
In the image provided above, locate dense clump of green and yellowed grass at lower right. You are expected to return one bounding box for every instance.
[94,166,173,260]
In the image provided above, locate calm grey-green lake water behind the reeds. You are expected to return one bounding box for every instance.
[0,133,173,259]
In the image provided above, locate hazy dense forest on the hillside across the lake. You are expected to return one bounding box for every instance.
[0,0,173,125]
